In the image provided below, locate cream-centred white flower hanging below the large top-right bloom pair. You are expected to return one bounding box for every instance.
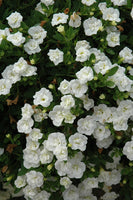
[106,31,120,47]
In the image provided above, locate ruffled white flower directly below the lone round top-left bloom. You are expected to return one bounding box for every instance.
[7,31,25,47]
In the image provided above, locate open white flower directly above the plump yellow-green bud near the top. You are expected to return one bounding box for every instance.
[51,13,68,26]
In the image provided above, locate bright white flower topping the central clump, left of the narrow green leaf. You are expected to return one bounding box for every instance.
[76,66,94,84]
